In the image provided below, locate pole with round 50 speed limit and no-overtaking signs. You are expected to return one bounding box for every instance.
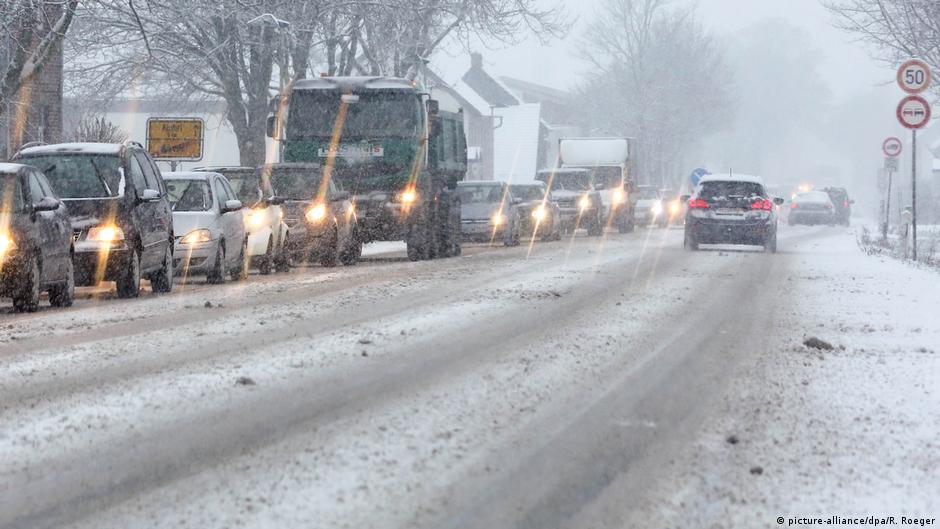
[897,59,933,261]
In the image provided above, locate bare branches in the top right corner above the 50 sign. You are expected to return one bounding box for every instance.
[823,0,940,95]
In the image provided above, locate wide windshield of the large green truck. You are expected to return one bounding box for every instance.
[287,90,421,139]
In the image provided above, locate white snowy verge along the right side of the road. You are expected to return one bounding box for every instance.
[628,228,940,527]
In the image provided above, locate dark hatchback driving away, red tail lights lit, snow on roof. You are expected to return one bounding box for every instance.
[683,175,783,253]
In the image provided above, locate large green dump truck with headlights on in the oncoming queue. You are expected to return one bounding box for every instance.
[268,77,467,261]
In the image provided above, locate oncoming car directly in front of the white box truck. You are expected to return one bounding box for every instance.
[535,168,604,237]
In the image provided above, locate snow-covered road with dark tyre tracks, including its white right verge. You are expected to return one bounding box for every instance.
[0,227,940,529]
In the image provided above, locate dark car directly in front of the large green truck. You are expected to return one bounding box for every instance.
[257,163,362,267]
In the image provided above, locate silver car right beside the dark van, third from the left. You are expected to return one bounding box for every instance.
[163,172,249,283]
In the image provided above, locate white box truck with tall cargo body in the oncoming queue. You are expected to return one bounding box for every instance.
[558,138,637,233]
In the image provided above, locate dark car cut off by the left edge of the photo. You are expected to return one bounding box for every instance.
[0,163,75,312]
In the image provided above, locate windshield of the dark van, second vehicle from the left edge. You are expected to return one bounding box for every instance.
[20,154,124,198]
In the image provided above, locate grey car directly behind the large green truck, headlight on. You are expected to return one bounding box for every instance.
[457,182,522,246]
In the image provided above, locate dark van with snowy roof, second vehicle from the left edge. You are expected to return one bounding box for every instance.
[14,142,173,298]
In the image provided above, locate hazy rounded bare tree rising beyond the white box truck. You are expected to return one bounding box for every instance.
[577,0,731,185]
